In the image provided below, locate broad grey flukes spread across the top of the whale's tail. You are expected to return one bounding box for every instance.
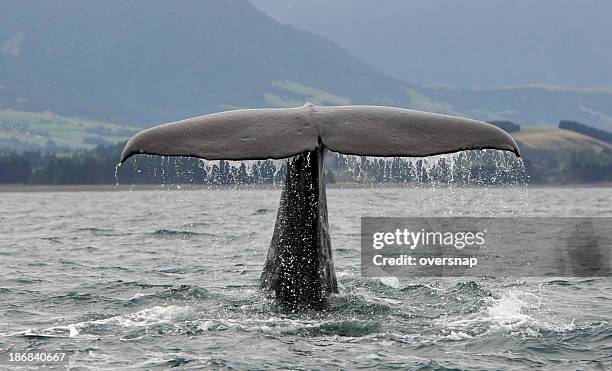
[121,104,520,162]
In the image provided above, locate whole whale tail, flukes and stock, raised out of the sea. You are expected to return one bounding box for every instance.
[121,104,520,309]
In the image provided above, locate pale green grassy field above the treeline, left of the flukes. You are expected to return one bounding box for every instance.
[0,110,140,151]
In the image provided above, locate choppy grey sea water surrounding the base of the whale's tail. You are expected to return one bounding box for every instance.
[0,188,612,370]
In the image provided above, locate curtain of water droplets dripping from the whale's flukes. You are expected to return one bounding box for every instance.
[115,150,528,215]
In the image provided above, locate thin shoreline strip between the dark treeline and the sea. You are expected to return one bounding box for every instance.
[0,182,612,193]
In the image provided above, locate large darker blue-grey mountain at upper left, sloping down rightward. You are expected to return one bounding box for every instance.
[0,0,409,125]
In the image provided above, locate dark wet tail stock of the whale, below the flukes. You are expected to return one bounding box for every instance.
[261,146,338,309]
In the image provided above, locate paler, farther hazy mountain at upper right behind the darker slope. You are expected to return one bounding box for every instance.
[252,0,612,87]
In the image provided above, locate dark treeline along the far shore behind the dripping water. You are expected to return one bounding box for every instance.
[0,143,612,185]
